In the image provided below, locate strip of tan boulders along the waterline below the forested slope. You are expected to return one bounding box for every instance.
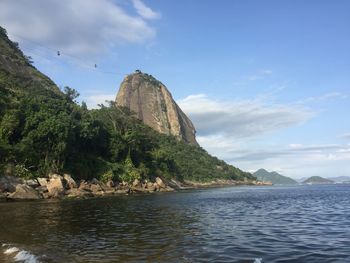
[0,174,271,201]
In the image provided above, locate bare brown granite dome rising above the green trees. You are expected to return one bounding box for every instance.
[116,71,197,145]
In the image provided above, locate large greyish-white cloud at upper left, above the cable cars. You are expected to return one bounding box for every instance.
[0,0,156,56]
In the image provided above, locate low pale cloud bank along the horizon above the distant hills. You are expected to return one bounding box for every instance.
[212,142,350,178]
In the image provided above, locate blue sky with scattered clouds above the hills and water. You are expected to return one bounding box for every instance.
[0,0,350,179]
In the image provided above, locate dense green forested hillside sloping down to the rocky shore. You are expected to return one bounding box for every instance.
[0,28,254,182]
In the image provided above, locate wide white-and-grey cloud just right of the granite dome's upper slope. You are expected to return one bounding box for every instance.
[178,94,314,139]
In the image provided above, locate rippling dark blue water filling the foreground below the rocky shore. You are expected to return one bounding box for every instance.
[0,185,350,263]
